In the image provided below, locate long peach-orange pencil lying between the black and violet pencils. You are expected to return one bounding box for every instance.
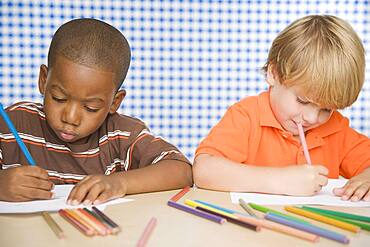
[237,214,320,242]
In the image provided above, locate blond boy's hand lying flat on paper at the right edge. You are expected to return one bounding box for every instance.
[333,168,370,202]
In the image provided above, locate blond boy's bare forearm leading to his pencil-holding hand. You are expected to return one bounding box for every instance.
[193,154,290,194]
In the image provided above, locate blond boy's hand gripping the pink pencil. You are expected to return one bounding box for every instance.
[281,165,329,196]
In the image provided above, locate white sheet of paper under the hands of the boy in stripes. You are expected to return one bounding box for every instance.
[0,185,132,213]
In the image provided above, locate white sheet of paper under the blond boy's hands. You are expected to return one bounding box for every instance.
[230,179,370,207]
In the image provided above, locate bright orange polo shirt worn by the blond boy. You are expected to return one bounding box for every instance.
[195,92,370,178]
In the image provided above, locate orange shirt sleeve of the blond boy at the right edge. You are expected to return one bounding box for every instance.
[339,127,370,178]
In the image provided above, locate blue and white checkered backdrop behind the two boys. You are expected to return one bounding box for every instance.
[0,0,370,159]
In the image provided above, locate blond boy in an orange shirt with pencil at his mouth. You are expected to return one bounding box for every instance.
[193,15,370,201]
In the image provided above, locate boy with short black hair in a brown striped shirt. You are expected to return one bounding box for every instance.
[0,19,192,205]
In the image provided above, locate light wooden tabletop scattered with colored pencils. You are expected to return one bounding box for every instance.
[0,188,370,247]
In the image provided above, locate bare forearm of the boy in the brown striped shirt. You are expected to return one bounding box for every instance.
[112,160,193,194]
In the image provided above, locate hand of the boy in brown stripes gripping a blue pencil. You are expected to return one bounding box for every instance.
[0,165,54,202]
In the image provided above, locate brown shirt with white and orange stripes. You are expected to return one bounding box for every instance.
[0,102,190,184]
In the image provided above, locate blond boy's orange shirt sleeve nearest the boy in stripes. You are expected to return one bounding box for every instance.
[195,103,251,163]
